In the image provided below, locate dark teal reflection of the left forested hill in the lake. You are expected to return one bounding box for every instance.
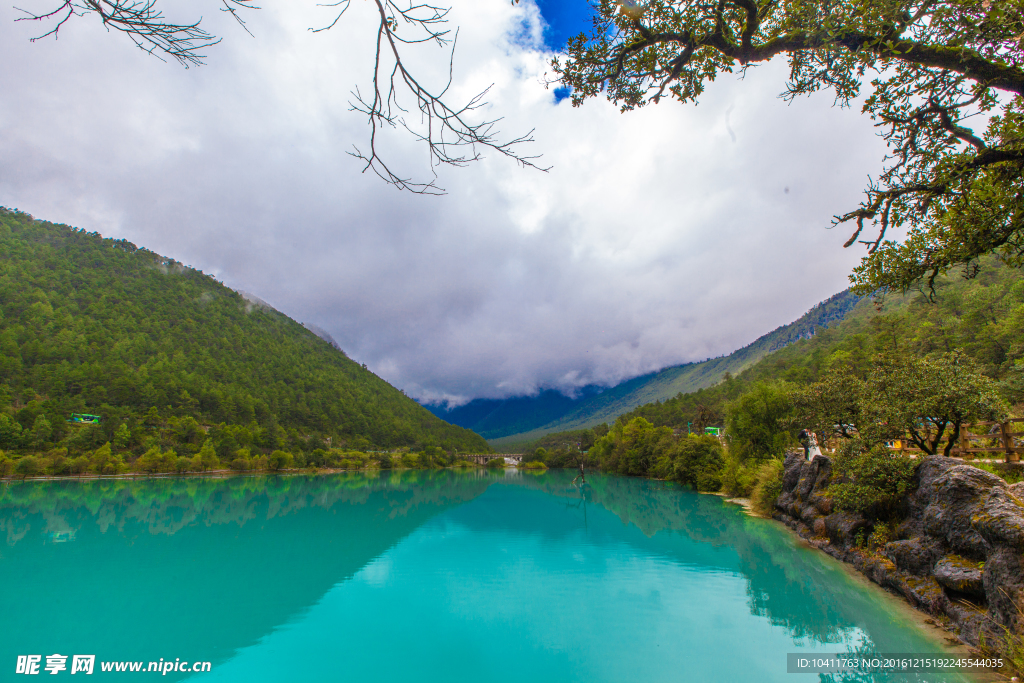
[0,471,490,666]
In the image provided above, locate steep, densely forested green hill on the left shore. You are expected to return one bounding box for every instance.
[0,209,486,452]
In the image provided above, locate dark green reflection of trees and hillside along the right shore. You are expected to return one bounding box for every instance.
[523,472,962,681]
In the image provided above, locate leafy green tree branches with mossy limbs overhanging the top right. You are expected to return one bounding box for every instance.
[553,0,1024,293]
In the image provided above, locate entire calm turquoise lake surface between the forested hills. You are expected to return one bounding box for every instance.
[0,470,964,683]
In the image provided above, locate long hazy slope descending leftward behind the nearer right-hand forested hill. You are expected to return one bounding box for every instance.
[489,291,860,450]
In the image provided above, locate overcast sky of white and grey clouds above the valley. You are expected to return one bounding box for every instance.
[0,0,884,402]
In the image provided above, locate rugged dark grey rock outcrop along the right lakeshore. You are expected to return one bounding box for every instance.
[774,453,1024,645]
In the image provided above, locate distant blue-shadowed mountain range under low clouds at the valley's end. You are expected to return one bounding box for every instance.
[468,291,860,446]
